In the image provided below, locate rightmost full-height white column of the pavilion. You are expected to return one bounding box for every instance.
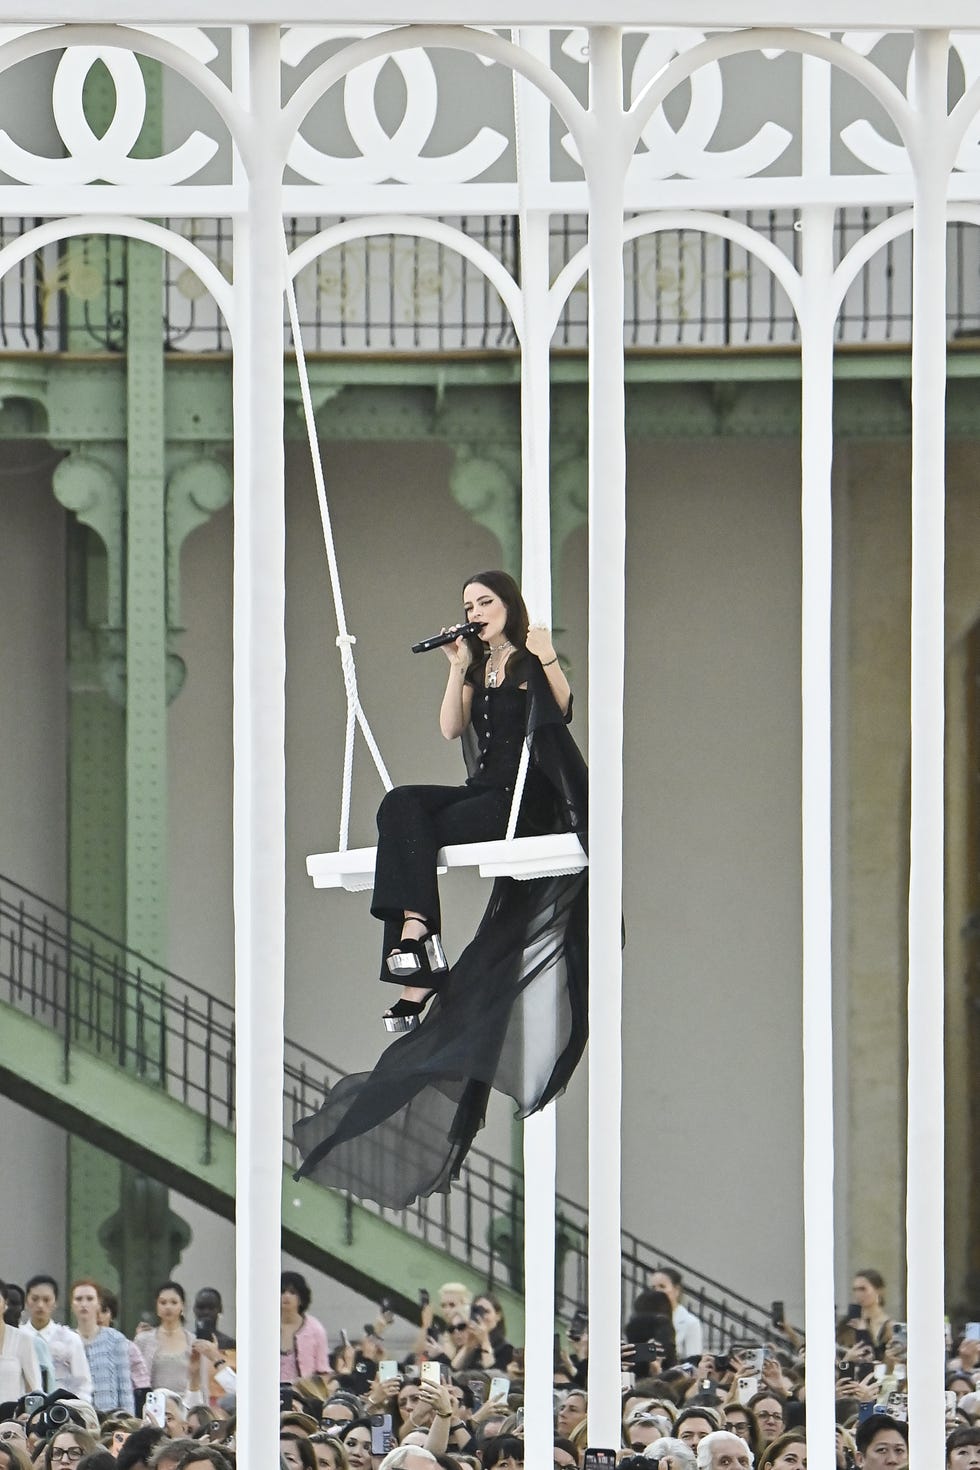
[907,31,949,1466]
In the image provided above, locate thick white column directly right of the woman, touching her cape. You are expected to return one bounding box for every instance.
[585,26,626,1448]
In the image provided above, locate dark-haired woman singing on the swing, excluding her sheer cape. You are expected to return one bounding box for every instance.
[370,572,572,1032]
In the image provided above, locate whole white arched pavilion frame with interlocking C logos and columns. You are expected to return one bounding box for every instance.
[0,14,980,1470]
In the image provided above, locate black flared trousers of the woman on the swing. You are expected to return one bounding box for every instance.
[370,786,511,983]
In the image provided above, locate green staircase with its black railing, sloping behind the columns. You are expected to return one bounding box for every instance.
[0,876,771,1347]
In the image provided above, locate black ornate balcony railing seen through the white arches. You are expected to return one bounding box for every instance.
[0,209,980,353]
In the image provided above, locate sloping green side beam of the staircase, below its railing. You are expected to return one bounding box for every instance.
[0,1001,525,1341]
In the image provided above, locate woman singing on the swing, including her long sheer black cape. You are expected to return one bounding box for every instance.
[292,572,588,1208]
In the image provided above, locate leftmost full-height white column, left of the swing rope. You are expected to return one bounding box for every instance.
[234,25,285,1470]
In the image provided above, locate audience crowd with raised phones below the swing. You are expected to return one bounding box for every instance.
[0,1267,980,1470]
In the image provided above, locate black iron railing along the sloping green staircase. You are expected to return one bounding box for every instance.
[0,876,771,1345]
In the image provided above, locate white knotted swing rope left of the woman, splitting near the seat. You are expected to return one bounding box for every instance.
[282,231,392,853]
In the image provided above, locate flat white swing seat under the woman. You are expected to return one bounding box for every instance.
[306,832,589,894]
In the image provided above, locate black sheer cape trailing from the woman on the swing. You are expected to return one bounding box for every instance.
[292,654,588,1208]
